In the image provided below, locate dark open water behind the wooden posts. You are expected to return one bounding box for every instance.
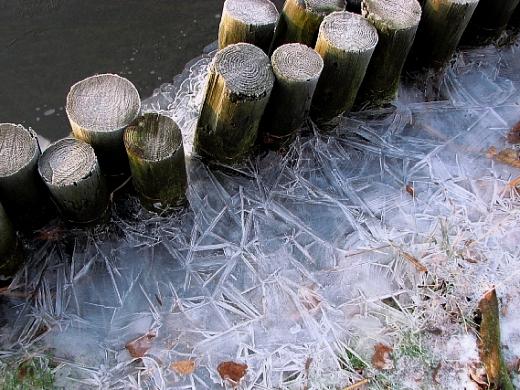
[0,0,282,139]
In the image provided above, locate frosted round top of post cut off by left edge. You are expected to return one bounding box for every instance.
[0,123,39,177]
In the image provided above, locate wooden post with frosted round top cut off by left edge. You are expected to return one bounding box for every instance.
[0,123,51,229]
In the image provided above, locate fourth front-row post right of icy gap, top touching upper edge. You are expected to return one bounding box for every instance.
[356,0,421,107]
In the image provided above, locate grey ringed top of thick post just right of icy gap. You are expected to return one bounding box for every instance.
[212,43,274,99]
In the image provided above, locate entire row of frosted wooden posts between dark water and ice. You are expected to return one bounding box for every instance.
[0,0,520,282]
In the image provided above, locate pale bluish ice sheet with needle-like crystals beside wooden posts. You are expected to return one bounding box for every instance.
[0,35,520,389]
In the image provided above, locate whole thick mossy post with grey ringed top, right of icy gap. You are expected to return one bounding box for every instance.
[193,43,274,163]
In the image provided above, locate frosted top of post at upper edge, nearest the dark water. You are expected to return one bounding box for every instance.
[224,0,278,26]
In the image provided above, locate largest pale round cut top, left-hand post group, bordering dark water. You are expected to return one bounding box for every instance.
[66,74,141,132]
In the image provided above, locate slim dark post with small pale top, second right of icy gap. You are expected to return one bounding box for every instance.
[261,43,323,147]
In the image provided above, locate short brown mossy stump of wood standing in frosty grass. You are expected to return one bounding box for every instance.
[478,288,514,390]
